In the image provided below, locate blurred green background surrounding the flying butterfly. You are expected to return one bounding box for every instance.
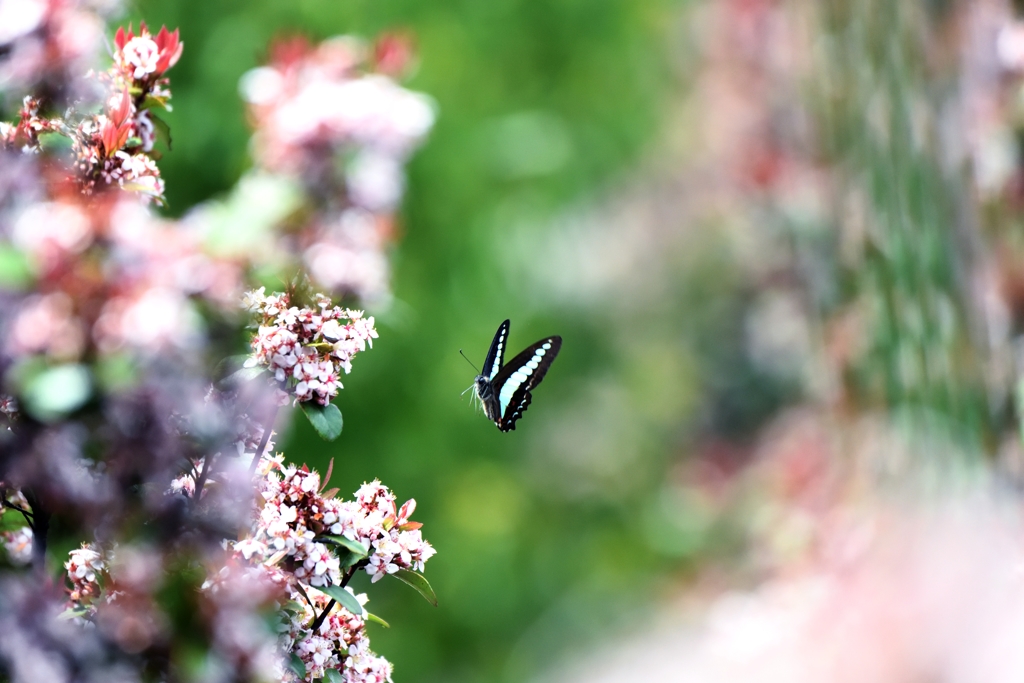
[117,0,942,683]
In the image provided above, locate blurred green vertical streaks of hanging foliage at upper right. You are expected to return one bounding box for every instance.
[812,0,1007,451]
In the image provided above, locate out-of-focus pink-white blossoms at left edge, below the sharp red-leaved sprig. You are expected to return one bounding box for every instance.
[3,197,241,361]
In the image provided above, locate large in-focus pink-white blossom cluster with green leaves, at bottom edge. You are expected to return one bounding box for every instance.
[219,456,436,683]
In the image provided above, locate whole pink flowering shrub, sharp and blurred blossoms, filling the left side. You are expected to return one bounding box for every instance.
[0,10,434,683]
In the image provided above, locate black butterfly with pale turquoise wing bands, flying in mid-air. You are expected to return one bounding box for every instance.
[466,321,562,432]
